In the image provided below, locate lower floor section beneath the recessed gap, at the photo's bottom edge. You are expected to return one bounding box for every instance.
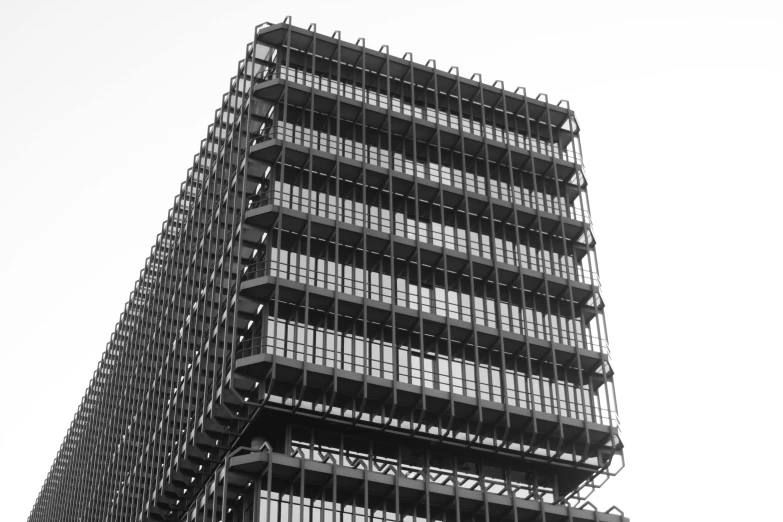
[176,447,628,522]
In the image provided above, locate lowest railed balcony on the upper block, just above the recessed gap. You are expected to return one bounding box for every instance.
[236,332,620,427]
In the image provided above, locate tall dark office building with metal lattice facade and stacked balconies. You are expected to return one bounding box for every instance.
[29,19,627,522]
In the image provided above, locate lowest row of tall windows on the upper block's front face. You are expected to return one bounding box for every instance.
[237,311,617,425]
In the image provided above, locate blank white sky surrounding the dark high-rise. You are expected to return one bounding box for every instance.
[0,0,783,522]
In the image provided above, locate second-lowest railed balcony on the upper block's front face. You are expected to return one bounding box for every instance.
[241,259,609,360]
